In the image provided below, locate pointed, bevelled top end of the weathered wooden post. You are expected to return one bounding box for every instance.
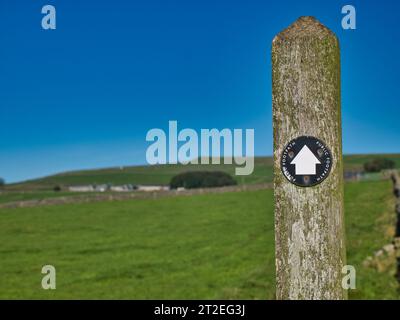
[274,16,336,41]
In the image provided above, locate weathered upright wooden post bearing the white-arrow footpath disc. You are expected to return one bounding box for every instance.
[272,17,347,299]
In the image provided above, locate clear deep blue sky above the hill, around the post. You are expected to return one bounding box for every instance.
[0,0,400,182]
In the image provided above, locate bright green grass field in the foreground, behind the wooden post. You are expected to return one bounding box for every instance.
[0,181,399,299]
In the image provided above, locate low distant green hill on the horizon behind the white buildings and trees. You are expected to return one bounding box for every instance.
[6,154,400,191]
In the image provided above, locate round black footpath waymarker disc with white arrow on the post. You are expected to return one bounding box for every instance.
[281,136,332,187]
